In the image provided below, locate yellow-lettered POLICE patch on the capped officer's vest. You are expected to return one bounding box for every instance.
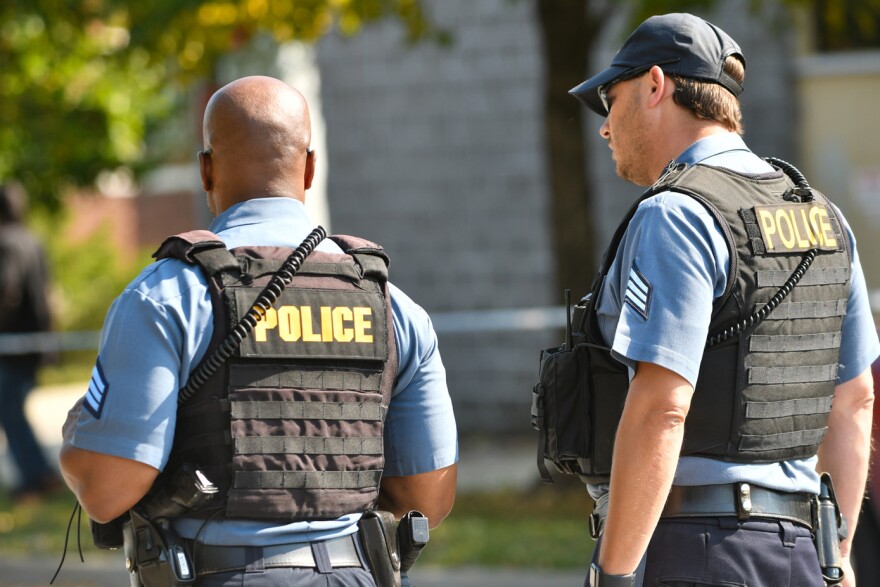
[755,204,837,252]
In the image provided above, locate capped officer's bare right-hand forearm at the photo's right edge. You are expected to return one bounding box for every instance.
[817,371,874,556]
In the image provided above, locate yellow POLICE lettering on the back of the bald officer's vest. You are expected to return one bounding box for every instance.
[254,306,373,343]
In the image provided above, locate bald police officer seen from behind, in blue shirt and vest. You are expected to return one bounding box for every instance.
[61,76,458,585]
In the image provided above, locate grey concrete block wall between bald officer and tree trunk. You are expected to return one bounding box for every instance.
[316,0,559,431]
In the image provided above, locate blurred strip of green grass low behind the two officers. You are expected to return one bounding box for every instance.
[0,480,593,569]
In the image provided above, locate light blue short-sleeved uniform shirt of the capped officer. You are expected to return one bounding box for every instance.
[591,133,880,497]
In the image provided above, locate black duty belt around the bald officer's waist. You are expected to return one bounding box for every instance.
[195,535,362,575]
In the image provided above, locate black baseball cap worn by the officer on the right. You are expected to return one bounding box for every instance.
[568,13,746,116]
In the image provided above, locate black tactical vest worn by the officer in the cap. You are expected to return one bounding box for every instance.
[588,165,851,463]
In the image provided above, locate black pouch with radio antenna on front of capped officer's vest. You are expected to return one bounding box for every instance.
[531,295,629,483]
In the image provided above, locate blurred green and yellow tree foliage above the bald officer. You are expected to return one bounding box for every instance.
[0,0,429,209]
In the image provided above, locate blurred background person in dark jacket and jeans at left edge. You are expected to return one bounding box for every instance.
[0,182,63,500]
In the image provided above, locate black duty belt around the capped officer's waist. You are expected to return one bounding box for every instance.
[661,483,813,530]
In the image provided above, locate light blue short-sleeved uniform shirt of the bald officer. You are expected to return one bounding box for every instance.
[72,198,458,546]
